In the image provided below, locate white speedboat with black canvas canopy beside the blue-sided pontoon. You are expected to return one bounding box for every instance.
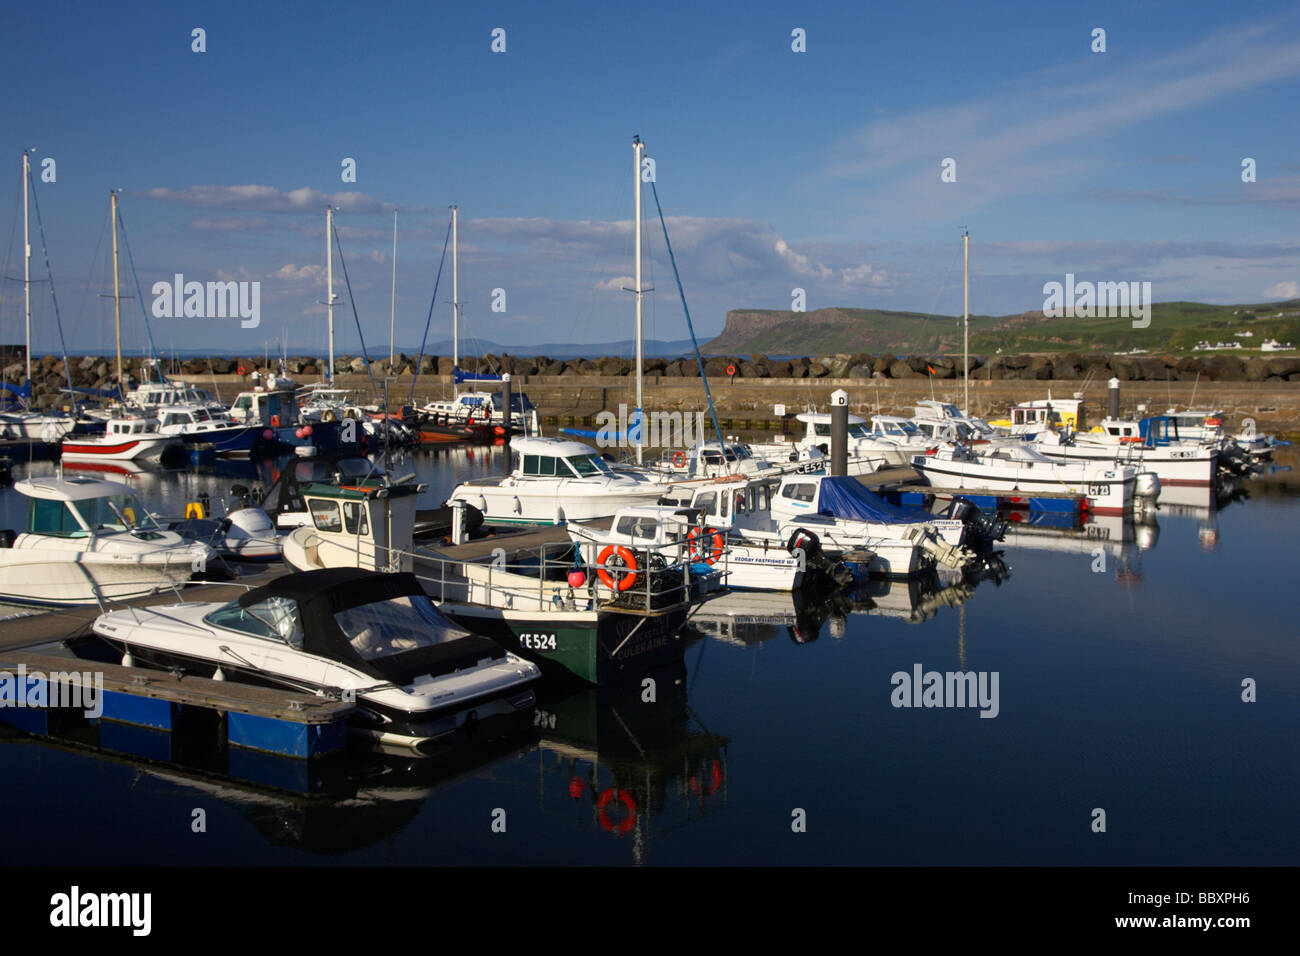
[82,568,541,747]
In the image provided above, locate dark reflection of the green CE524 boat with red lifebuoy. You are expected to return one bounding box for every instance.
[534,661,731,865]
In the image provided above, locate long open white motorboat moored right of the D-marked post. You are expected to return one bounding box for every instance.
[911,445,1144,515]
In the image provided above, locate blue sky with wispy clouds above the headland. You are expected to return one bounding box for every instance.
[0,0,1300,356]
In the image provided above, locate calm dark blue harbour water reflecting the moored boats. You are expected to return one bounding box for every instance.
[0,450,1300,865]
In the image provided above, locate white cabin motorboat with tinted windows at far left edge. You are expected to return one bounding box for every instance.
[0,477,215,605]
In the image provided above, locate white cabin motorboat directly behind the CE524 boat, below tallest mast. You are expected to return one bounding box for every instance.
[447,438,663,524]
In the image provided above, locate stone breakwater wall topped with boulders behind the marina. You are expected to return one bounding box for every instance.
[4,352,1300,431]
